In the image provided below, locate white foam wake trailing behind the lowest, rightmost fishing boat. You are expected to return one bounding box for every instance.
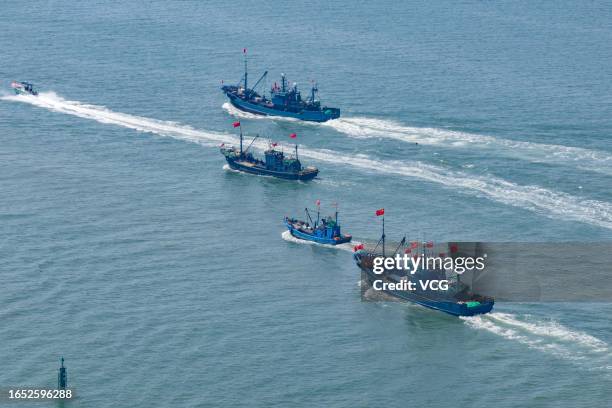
[462,312,610,361]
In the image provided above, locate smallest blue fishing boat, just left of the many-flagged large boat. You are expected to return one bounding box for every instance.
[284,200,353,245]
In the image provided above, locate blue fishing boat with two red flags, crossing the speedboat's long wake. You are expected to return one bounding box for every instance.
[220,122,319,181]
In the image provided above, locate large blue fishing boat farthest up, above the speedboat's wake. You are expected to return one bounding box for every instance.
[221,49,340,122]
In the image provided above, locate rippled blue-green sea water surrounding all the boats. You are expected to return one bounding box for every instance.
[0,1,612,407]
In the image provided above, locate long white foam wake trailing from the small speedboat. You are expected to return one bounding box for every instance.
[7,93,612,233]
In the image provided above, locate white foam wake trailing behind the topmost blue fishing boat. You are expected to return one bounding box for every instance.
[323,117,612,174]
